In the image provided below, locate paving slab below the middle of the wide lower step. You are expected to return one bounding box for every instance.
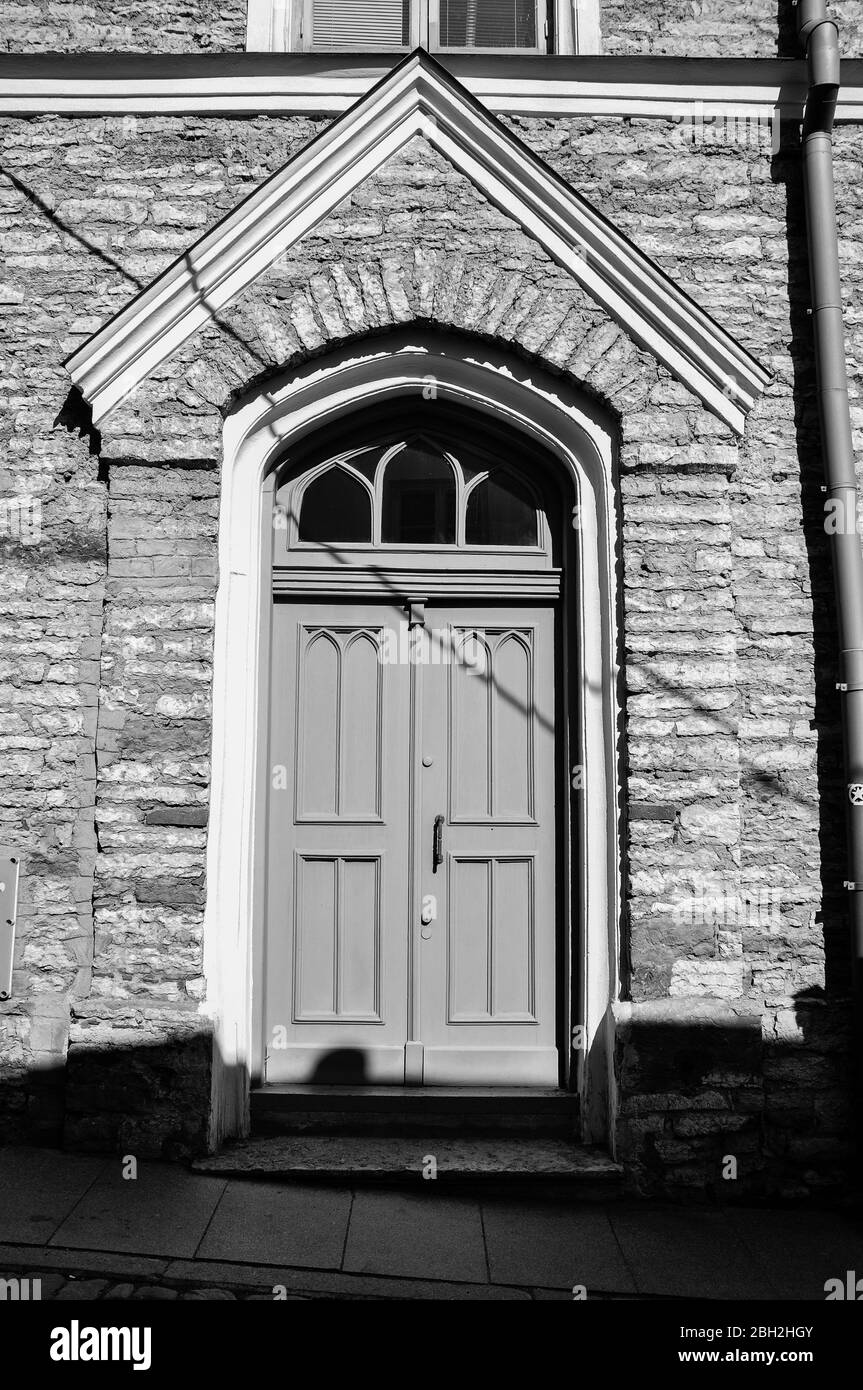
[343,1191,488,1283]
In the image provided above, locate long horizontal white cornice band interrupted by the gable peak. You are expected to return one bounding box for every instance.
[0,52,863,121]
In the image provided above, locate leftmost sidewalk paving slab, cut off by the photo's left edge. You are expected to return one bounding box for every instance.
[0,1148,108,1245]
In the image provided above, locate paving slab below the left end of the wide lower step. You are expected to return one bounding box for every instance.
[196,1182,352,1269]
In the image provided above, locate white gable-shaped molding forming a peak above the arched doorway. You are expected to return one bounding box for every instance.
[67,51,769,434]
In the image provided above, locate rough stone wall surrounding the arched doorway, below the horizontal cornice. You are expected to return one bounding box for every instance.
[0,105,863,1194]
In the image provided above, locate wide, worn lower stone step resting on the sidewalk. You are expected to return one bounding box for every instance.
[193,1134,623,1200]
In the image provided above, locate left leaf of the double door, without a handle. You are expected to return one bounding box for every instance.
[264,603,410,1084]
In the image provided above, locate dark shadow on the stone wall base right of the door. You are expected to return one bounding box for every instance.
[616,991,859,1202]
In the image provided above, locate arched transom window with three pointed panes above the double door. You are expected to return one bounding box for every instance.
[278,434,548,549]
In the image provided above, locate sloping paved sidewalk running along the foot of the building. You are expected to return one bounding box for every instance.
[0,1148,863,1301]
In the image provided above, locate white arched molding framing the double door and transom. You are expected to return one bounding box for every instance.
[200,331,621,1147]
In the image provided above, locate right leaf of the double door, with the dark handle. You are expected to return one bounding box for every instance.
[420,605,559,1086]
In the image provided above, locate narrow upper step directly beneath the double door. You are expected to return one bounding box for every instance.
[252,1086,578,1140]
